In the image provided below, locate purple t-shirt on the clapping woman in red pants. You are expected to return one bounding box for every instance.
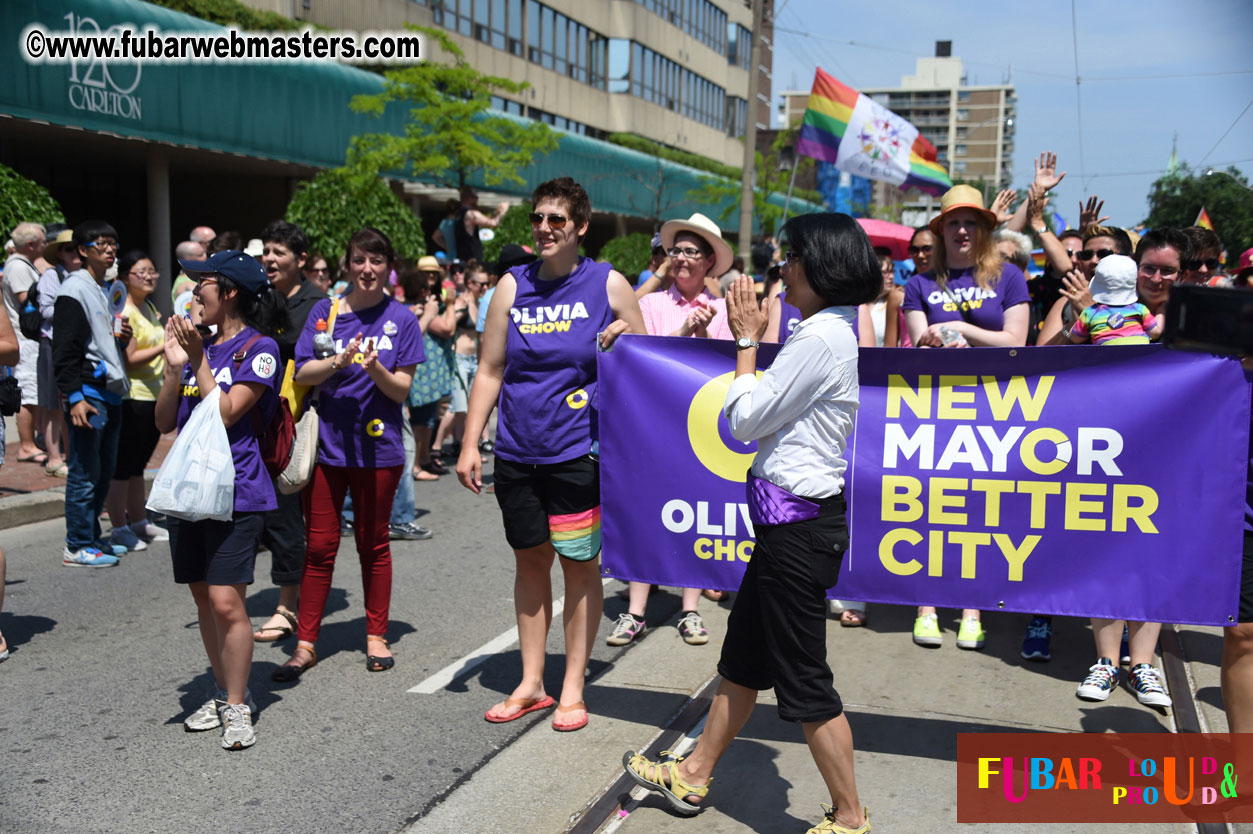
[296,298,426,468]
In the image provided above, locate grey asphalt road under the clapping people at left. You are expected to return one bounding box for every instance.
[0,468,678,834]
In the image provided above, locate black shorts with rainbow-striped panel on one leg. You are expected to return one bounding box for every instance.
[495,455,600,562]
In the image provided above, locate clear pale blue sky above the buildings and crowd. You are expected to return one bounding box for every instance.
[772,0,1253,234]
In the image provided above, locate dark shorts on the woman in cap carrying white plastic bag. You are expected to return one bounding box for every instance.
[167,512,266,585]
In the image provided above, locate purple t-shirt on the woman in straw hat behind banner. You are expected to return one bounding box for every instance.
[901,263,1031,331]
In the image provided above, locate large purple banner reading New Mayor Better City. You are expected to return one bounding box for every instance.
[600,337,1249,625]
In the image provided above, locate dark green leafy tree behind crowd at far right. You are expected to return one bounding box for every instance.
[1144,164,1253,255]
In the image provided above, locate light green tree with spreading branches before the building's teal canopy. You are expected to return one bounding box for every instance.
[348,25,558,188]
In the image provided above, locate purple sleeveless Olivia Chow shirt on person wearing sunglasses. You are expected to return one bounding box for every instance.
[495,258,614,463]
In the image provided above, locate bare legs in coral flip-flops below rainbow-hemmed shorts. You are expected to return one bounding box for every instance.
[490,542,604,724]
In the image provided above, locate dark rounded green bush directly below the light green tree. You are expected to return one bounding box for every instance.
[287,168,426,260]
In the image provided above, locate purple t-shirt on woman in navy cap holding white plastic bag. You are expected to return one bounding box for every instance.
[178,327,283,512]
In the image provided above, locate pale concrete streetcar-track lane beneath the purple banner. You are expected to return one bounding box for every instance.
[402,593,1232,834]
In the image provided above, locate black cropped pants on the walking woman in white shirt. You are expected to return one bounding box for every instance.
[718,496,848,721]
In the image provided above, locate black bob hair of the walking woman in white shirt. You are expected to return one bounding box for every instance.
[783,212,883,306]
